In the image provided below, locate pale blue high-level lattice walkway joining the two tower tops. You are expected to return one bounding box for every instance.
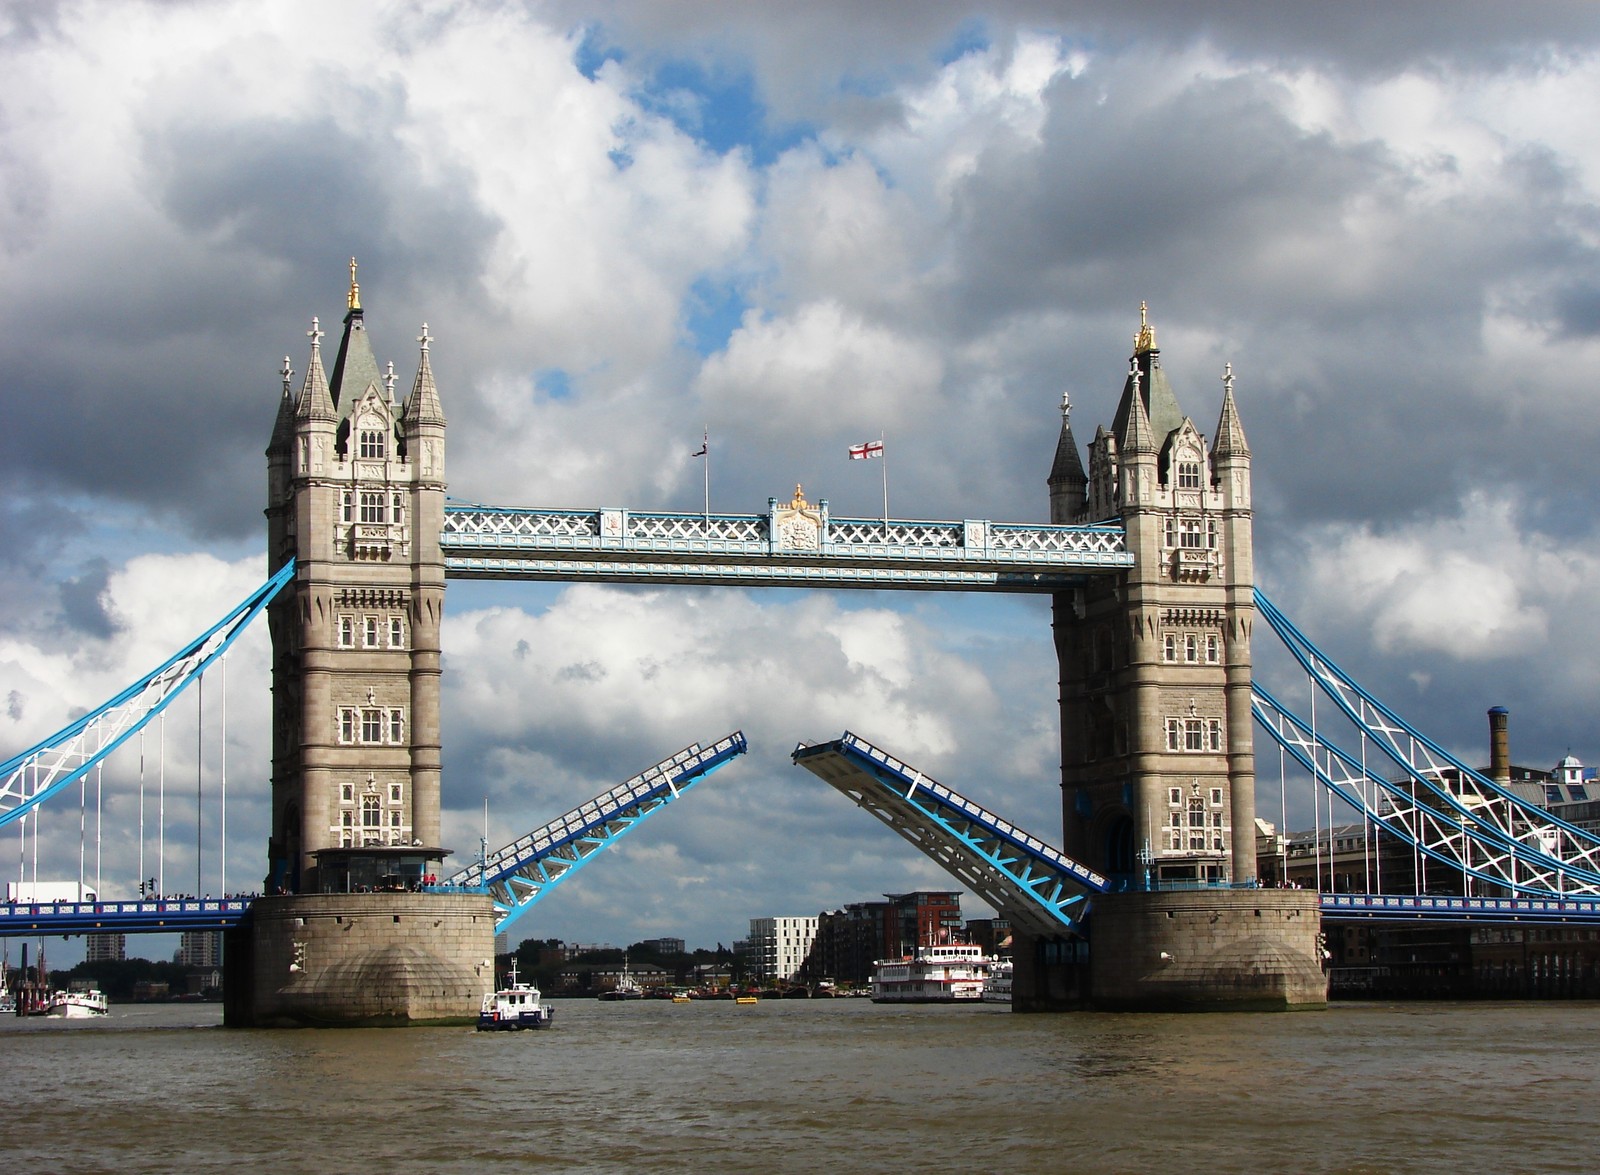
[440,499,1133,592]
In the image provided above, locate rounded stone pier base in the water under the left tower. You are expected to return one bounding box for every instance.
[224,893,494,1028]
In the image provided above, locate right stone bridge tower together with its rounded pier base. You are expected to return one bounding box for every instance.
[1046,306,1326,1007]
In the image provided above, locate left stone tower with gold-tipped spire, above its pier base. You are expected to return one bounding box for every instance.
[267,261,445,893]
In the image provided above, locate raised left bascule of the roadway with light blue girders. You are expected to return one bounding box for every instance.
[435,730,749,933]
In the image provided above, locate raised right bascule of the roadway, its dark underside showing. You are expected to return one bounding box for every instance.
[794,730,1110,938]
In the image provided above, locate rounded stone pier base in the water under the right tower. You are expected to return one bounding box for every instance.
[1088,890,1328,1012]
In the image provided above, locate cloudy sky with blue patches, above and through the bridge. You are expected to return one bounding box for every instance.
[0,0,1600,956]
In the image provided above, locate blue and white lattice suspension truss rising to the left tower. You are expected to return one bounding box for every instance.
[0,559,294,828]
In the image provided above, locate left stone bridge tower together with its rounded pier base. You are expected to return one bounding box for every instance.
[230,259,494,1023]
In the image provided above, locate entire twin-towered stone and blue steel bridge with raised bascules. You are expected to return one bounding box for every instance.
[0,273,1600,1025]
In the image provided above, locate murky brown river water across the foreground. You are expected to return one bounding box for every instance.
[0,999,1600,1175]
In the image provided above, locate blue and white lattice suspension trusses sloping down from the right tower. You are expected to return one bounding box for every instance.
[1251,591,1600,895]
